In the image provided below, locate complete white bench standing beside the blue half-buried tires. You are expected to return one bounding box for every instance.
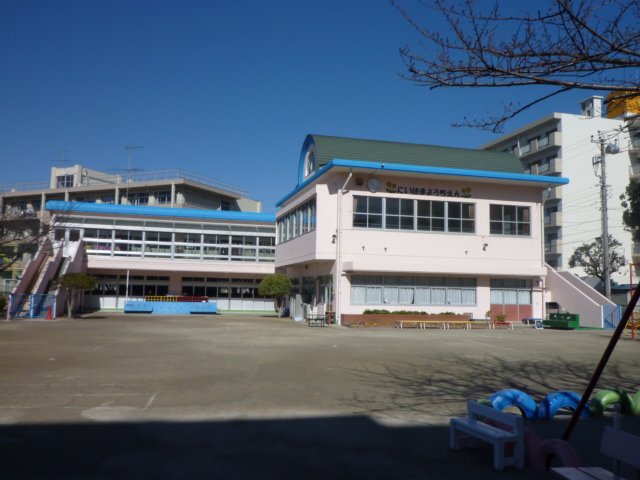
[449,401,524,470]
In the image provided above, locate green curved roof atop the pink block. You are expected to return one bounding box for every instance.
[311,135,524,173]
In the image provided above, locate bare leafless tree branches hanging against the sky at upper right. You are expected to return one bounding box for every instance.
[389,0,640,132]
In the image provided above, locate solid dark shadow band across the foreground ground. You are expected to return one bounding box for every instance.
[5,416,638,480]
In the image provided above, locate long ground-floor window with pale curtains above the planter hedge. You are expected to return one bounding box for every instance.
[351,275,477,306]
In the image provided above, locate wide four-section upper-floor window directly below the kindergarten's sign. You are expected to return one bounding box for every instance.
[353,196,475,233]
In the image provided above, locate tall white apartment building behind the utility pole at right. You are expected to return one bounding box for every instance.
[479,96,640,283]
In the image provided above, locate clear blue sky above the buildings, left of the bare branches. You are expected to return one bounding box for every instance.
[0,0,592,212]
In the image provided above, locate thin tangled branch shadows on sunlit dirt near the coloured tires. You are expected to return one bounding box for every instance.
[343,355,640,419]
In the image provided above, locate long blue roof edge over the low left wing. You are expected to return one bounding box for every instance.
[46,200,276,223]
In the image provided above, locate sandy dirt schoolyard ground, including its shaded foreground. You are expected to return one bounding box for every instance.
[0,313,640,480]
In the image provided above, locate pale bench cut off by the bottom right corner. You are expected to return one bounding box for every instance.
[551,427,640,480]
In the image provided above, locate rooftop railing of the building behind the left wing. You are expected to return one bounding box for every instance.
[0,169,248,197]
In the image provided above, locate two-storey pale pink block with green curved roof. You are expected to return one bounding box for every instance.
[275,135,569,321]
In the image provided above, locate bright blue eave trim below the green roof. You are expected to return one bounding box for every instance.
[276,159,569,207]
